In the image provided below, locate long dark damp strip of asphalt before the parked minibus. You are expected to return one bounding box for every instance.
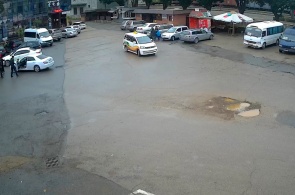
[182,44,295,76]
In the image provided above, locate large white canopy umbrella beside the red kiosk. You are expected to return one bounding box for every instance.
[213,11,253,34]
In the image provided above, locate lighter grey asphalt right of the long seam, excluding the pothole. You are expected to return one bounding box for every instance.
[63,22,295,195]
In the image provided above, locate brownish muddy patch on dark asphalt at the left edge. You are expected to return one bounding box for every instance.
[0,156,31,173]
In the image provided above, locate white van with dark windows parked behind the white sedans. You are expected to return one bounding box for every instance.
[24,28,53,46]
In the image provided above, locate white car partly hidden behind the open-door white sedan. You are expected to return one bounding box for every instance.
[3,47,42,66]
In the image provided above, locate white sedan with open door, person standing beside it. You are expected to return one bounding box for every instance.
[17,54,54,72]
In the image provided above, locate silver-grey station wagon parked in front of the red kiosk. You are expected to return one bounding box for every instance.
[180,29,214,43]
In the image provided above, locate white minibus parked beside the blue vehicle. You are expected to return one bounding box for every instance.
[244,21,284,49]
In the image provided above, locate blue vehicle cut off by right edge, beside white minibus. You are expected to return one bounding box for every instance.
[279,27,295,53]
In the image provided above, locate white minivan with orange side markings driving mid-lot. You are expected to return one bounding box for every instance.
[123,33,158,56]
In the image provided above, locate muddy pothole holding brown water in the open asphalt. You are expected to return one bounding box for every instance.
[203,97,261,120]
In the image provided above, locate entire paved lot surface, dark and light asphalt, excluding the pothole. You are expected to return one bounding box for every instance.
[0,20,295,195]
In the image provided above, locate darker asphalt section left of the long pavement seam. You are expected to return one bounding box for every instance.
[0,40,129,195]
